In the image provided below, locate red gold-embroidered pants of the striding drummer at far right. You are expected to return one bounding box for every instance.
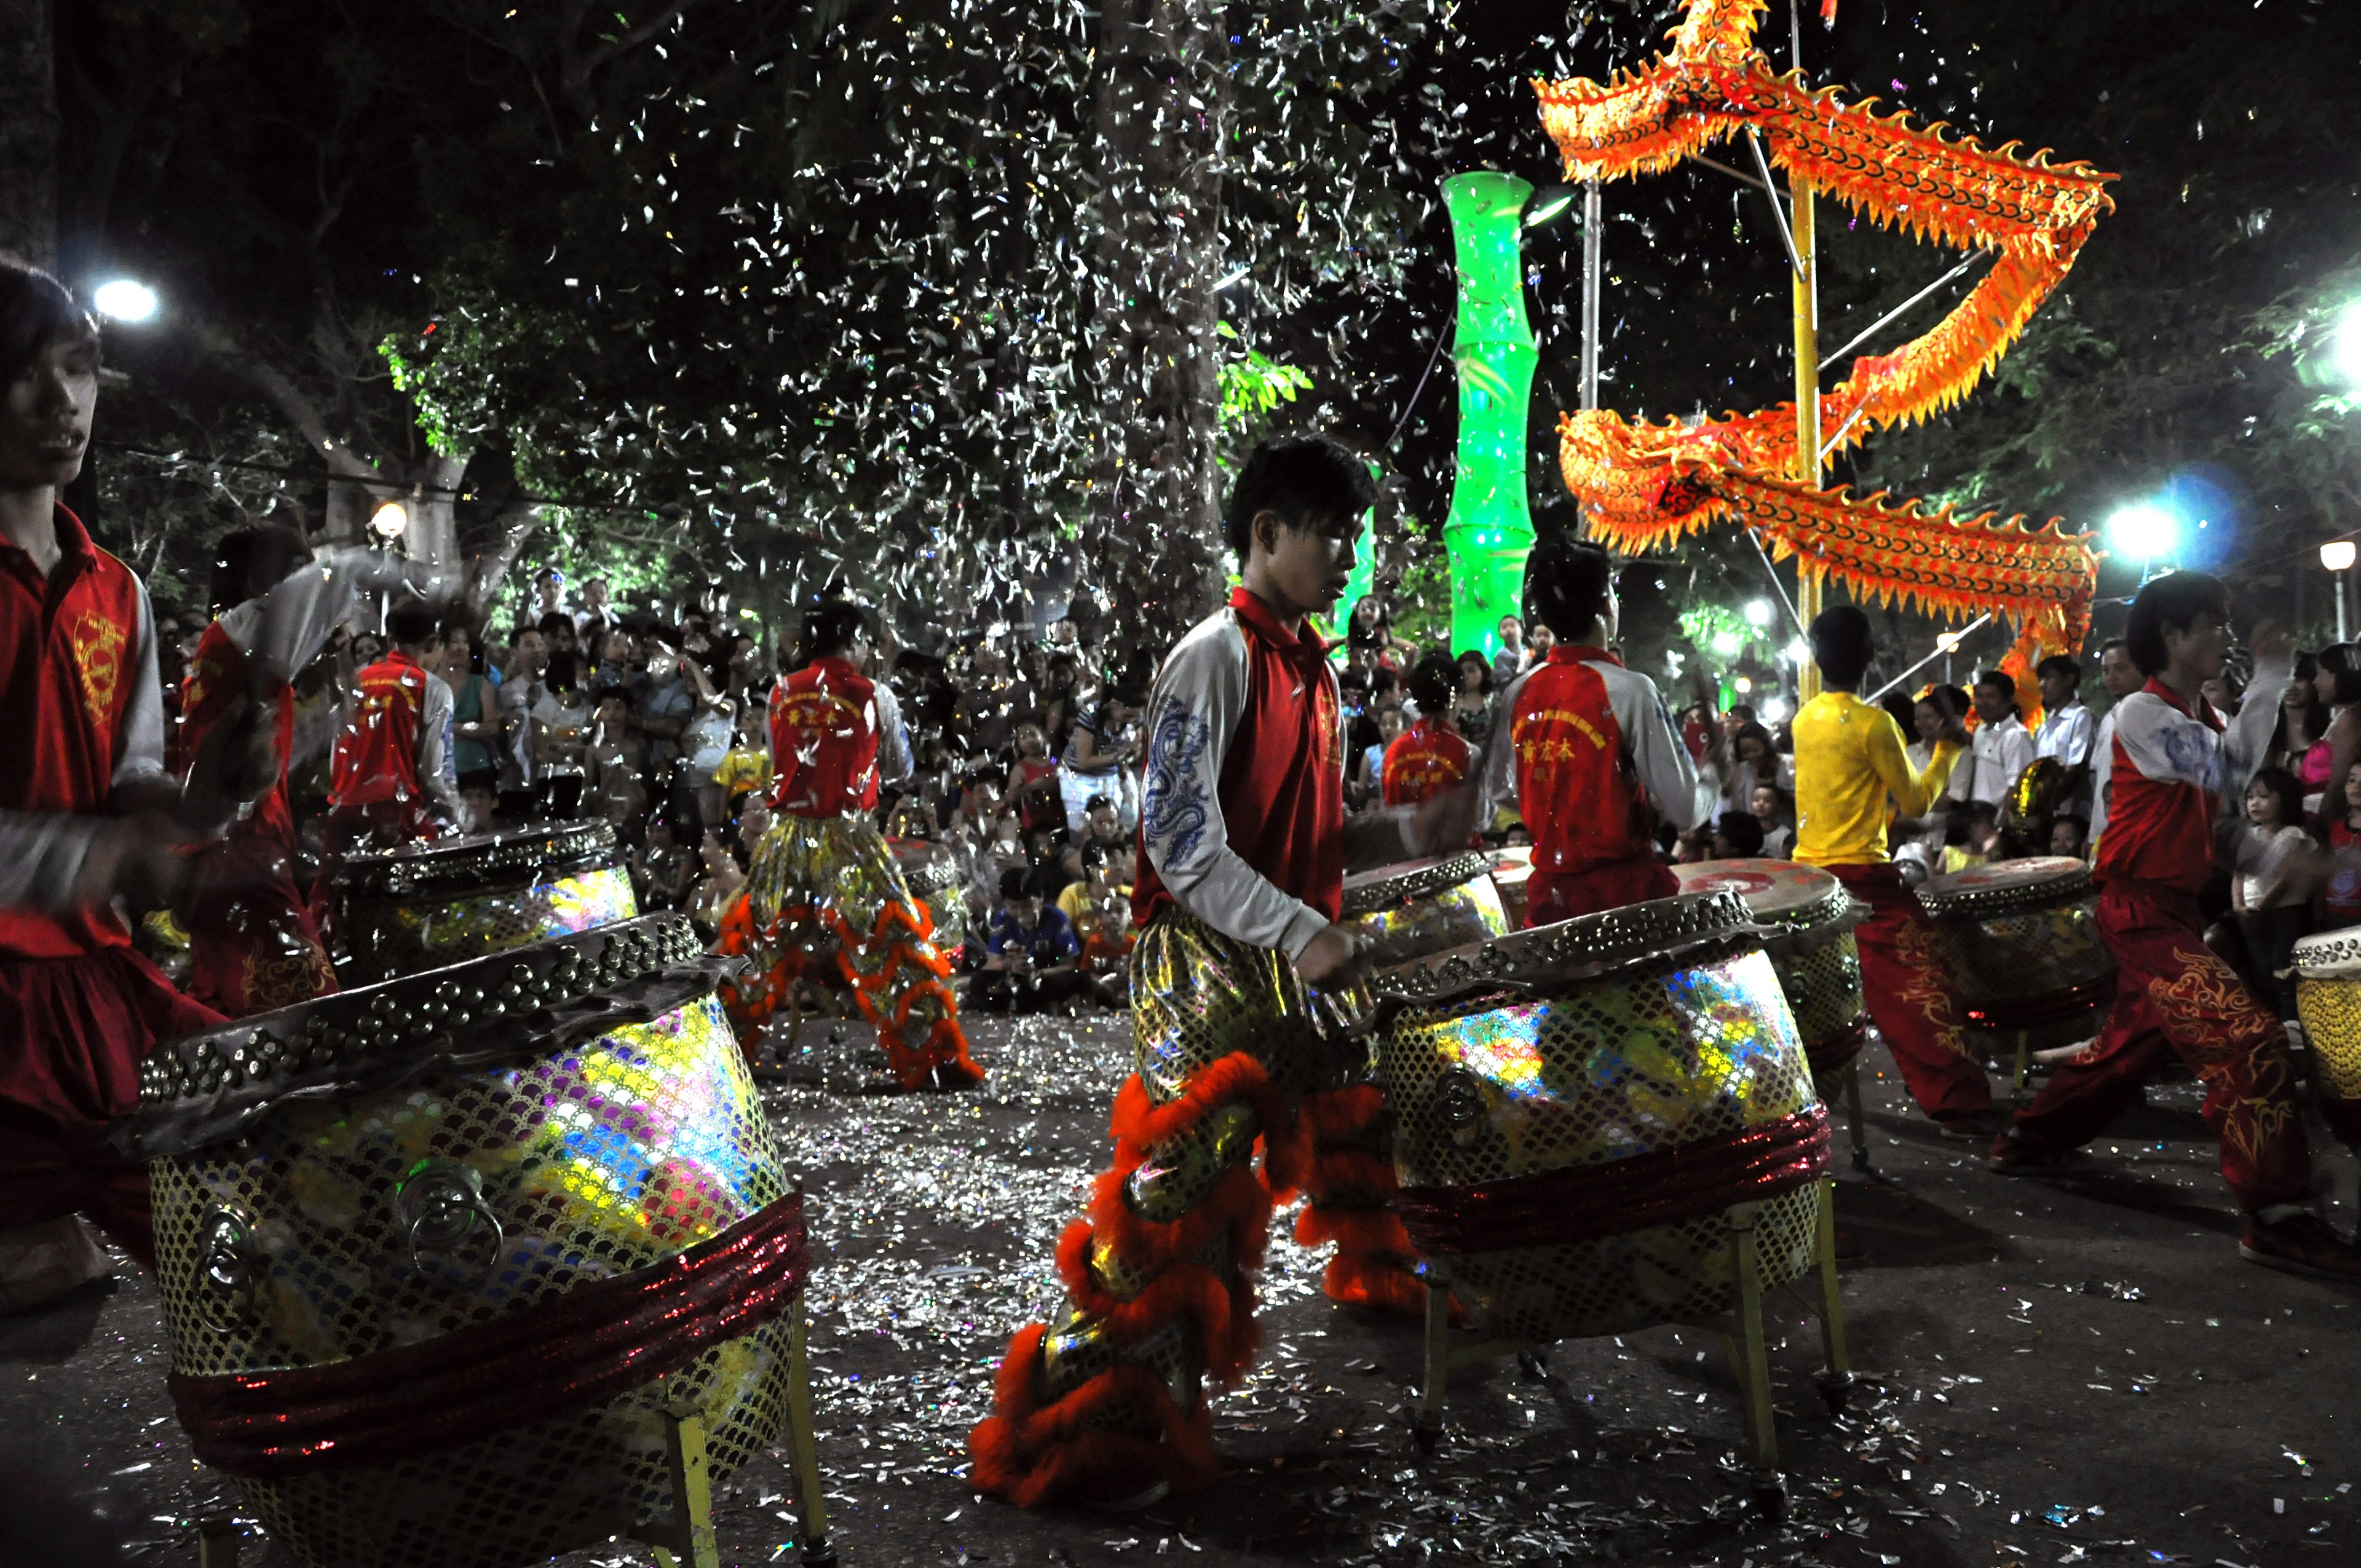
[2016,879,2311,1214]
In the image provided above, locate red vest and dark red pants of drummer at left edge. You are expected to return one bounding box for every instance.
[0,508,222,1264]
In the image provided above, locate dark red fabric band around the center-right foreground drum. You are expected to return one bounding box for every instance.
[1395,1105,1827,1256]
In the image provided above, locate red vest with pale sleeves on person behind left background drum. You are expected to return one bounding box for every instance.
[328,647,461,850]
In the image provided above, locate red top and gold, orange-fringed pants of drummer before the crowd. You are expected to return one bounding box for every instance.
[720,659,984,1088]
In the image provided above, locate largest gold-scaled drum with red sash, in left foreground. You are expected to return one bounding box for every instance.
[116,914,805,1568]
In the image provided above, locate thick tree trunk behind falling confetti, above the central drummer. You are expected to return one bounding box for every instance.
[1091,0,1230,652]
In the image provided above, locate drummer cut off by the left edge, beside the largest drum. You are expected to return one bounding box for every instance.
[0,259,267,1306]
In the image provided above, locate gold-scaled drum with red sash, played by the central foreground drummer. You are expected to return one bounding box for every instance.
[1372,893,1827,1344]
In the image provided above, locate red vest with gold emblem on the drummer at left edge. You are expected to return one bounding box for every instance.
[0,508,140,959]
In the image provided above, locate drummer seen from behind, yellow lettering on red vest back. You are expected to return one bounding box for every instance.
[1485,536,1698,925]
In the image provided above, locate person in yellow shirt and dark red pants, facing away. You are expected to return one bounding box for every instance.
[1794,604,2002,1138]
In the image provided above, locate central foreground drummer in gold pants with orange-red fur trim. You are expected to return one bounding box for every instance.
[968,435,1478,1507]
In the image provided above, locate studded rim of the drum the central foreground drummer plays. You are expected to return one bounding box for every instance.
[1369,888,1759,1004]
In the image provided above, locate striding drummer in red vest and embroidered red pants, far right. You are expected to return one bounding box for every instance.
[1990,571,2361,1282]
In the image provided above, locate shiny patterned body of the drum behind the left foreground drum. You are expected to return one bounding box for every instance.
[333,822,640,987]
